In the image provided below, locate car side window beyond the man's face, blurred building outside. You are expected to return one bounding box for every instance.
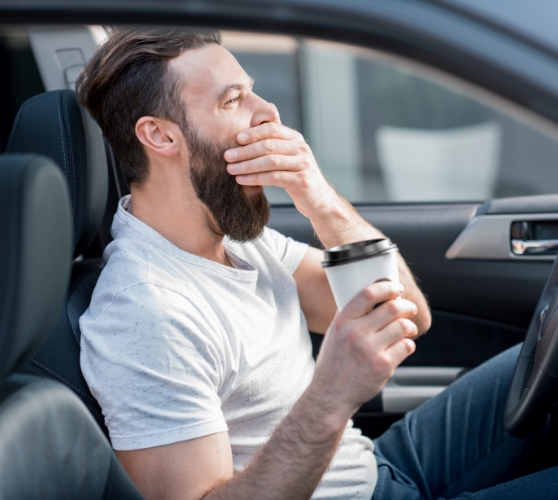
[224,32,558,204]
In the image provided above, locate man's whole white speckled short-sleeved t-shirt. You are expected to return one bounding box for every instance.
[80,197,377,500]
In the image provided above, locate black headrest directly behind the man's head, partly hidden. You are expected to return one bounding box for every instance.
[6,90,108,257]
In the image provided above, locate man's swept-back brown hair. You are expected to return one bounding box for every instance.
[76,29,221,185]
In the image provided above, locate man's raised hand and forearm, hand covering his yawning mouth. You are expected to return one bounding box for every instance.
[225,119,430,334]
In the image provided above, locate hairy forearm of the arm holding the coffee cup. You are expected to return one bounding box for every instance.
[203,388,350,500]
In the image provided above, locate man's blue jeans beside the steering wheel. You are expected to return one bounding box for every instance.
[373,346,558,500]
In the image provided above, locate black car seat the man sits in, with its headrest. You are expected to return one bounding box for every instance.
[6,90,112,435]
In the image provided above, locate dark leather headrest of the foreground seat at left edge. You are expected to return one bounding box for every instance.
[0,154,72,381]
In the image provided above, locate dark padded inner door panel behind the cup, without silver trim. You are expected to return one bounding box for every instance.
[270,201,551,374]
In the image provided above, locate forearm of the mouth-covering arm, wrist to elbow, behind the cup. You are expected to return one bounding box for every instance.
[308,188,431,335]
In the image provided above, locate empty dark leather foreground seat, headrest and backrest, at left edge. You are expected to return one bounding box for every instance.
[0,155,141,500]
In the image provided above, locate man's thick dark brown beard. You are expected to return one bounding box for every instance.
[185,127,270,243]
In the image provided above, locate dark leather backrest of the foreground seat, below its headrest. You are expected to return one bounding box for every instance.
[0,374,142,500]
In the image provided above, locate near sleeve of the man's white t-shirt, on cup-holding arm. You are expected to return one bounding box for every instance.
[80,284,228,450]
